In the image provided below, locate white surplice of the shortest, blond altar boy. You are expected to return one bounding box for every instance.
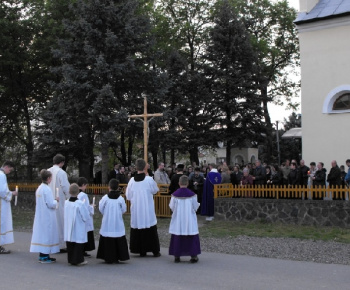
[64,200,90,244]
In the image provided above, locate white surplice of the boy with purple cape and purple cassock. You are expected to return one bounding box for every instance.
[169,195,199,236]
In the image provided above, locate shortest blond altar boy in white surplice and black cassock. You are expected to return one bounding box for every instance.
[64,183,90,266]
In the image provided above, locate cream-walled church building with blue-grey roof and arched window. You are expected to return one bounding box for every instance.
[295,0,350,168]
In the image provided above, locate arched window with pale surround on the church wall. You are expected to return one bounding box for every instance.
[322,85,350,114]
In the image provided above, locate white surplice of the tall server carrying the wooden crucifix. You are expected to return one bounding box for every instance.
[126,176,159,229]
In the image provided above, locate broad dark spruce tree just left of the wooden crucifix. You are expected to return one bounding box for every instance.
[40,0,157,181]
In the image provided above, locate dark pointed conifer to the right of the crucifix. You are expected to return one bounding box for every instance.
[206,0,262,162]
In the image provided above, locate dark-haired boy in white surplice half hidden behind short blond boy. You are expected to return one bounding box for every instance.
[77,177,96,258]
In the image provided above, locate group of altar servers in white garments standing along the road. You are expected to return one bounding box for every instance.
[0,154,201,266]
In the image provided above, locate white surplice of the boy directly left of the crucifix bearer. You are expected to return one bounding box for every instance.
[98,194,126,238]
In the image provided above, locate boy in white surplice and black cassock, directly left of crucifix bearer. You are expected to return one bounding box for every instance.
[97,178,130,264]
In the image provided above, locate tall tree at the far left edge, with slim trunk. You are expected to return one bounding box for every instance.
[0,0,49,180]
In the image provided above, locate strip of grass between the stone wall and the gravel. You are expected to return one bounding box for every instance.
[12,209,350,243]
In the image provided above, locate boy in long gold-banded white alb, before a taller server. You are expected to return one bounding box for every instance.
[30,169,60,264]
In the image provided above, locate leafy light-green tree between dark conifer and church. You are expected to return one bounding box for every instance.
[230,0,299,161]
